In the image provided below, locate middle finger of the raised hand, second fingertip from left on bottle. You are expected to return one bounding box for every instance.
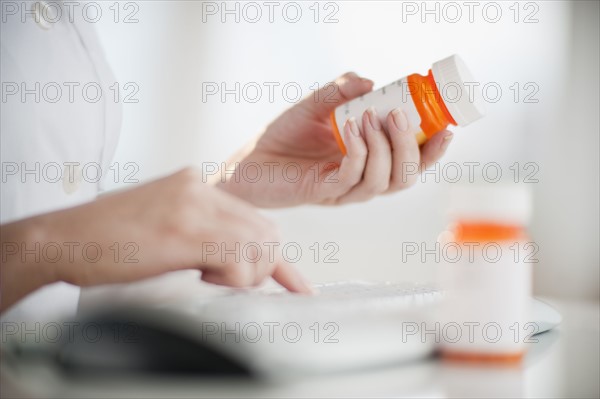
[339,108,392,203]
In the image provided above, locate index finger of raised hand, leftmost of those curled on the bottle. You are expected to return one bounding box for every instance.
[317,118,367,203]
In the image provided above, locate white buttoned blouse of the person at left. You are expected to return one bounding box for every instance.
[0,1,121,322]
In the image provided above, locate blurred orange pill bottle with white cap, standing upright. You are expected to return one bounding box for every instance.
[438,184,536,363]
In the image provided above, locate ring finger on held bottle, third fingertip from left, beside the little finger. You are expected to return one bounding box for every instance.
[386,108,421,192]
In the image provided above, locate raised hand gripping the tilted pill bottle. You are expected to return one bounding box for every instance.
[215,73,452,207]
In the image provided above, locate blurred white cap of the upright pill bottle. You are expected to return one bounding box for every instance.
[449,182,532,227]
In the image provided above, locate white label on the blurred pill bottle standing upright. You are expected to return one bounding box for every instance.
[436,241,538,354]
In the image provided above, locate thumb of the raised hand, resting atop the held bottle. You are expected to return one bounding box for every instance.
[298,72,373,118]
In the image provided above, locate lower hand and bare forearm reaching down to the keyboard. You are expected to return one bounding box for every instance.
[0,169,310,309]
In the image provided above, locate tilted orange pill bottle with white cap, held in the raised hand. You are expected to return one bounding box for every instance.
[331,55,485,154]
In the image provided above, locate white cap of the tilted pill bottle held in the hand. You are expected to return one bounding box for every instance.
[431,55,485,126]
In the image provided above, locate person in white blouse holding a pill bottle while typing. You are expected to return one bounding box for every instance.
[1,2,452,320]
